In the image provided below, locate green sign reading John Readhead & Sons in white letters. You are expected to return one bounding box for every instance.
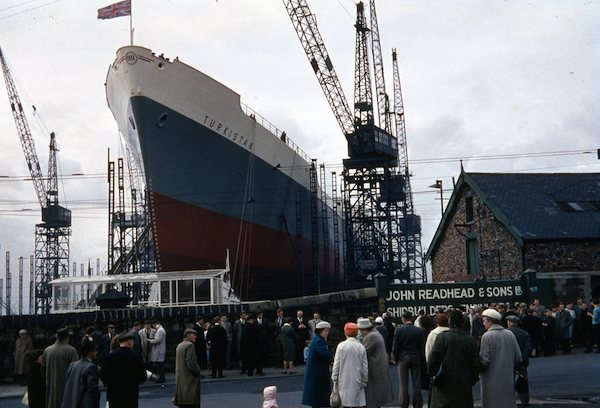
[385,280,526,317]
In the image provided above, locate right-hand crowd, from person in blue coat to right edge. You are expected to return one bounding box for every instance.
[302,299,600,408]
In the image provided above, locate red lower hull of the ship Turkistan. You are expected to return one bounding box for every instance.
[151,193,339,300]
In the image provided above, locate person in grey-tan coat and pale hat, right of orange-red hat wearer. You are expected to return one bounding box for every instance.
[357,318,394,408]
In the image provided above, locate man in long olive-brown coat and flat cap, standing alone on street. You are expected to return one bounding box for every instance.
[173,329,200,408]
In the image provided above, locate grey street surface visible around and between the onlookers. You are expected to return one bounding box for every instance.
[0,348,600,408]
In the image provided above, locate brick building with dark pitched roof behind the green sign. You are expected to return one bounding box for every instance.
[427,172,600,299]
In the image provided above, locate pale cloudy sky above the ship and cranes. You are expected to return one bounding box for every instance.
[0,0,600,310]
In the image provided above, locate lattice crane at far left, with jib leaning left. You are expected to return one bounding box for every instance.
[0,48,71,314]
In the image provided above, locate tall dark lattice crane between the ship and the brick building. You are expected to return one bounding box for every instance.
[283,0,426,287]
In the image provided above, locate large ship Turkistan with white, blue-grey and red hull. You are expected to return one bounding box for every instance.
[105,45,345,300]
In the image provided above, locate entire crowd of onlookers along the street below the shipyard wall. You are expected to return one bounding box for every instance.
[5,299,600,408]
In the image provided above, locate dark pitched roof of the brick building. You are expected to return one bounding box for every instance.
[427,173,600,256]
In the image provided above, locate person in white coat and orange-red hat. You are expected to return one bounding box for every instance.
[331,323,369,407]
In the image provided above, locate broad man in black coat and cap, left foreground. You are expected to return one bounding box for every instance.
[100,333,147,408]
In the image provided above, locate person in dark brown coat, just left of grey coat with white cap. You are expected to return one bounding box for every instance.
[427,310,479,408]
